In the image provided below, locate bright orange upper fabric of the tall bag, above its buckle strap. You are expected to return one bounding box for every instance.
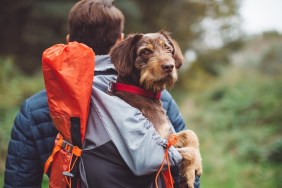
[42,42,95,143]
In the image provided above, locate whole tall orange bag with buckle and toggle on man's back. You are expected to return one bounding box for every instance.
[42,42,95,188]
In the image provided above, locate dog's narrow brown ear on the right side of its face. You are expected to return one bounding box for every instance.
[159,30,185,69]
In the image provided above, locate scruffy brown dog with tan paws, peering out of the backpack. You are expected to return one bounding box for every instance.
[110,31,202,188]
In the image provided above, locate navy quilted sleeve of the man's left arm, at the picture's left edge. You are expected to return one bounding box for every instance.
[4,100,43,188]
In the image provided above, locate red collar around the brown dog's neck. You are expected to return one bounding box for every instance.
[109,82,161,100]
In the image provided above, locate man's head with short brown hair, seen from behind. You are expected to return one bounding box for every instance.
[68,0,124,55]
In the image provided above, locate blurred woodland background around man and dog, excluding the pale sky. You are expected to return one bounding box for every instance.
[0,0,282,188]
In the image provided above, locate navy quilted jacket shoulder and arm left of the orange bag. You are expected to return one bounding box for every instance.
[4,90,57,187]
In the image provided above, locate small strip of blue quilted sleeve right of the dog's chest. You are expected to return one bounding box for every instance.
[161,90,186,132]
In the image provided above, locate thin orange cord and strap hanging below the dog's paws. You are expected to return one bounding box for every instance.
[155,135,177,188]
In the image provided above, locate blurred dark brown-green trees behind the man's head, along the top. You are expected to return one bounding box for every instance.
[0,0,238,74]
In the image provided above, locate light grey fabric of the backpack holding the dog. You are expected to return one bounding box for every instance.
[80,56,182,187]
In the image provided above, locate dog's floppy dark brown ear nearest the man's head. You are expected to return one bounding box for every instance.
[110,34,143,76]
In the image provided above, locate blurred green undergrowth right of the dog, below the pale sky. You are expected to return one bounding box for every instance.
[174,35,282,188]
